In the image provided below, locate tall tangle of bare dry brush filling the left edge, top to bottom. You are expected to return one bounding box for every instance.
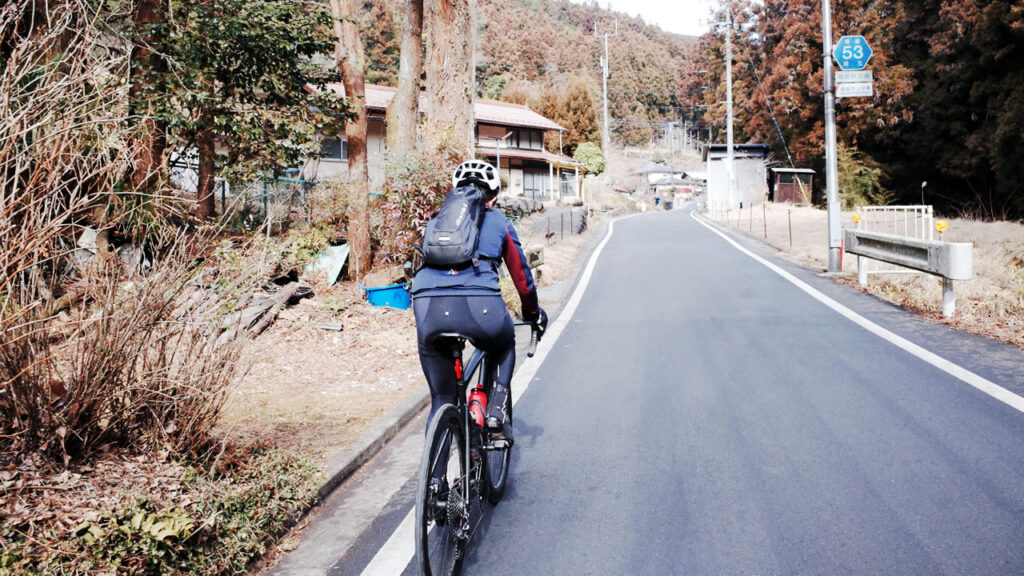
[0,0,258,464]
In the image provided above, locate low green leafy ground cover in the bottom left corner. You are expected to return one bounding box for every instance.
[0,449,321,576]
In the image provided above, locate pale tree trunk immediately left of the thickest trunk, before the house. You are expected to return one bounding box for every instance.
[386,0,423,157]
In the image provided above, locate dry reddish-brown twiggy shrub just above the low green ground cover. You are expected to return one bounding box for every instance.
[0,230,254,463]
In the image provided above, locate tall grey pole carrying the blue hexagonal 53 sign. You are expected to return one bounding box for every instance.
[821,0,843,273]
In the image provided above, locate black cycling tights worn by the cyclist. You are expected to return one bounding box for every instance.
[413,294,515,422]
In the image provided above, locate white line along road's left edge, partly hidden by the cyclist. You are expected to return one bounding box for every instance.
[362,213,622,576]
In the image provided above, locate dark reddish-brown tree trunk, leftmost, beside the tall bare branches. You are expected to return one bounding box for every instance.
[129,0,167,190]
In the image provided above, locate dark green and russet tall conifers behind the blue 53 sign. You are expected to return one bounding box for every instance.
[685,0,1024,218]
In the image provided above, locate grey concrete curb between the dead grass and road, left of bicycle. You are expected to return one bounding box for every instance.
[316,385,430,501]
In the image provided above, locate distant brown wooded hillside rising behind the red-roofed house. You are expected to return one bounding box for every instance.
[356,0,696,152]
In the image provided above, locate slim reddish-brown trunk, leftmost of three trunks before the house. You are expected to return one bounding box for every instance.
[331,0,371,280]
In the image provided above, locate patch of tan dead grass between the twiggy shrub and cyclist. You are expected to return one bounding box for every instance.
[219,282,424,467]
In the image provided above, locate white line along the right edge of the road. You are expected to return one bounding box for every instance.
[690,210,1024,412]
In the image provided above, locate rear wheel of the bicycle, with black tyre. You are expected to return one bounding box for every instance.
[416,404,470,576]
